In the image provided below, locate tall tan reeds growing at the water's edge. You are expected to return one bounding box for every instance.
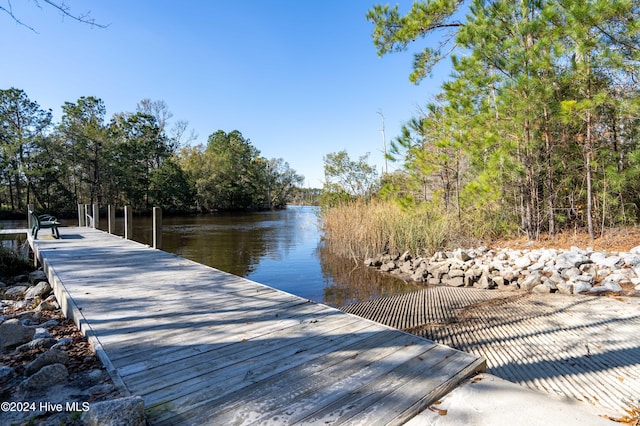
[322,200,468,259]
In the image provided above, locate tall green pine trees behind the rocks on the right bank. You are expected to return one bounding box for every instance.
[360,0,640,238]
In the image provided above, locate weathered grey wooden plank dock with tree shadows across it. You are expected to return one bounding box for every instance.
[30,228,485,425]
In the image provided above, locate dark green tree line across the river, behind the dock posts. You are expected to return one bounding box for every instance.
[0,88,304,214]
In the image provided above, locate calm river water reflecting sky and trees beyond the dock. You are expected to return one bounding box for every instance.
[4,206,418,306]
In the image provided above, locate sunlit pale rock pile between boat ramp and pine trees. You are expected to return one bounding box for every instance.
[364,246,640,294]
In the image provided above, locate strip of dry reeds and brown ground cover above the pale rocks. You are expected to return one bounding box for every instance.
[321,199,640,261]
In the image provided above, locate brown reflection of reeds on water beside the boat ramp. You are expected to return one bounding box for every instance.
[318,244,421,307]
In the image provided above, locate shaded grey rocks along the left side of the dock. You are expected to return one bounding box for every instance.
[0,271,144,426]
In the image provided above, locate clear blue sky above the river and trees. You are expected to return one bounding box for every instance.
[0,0,448,187]
